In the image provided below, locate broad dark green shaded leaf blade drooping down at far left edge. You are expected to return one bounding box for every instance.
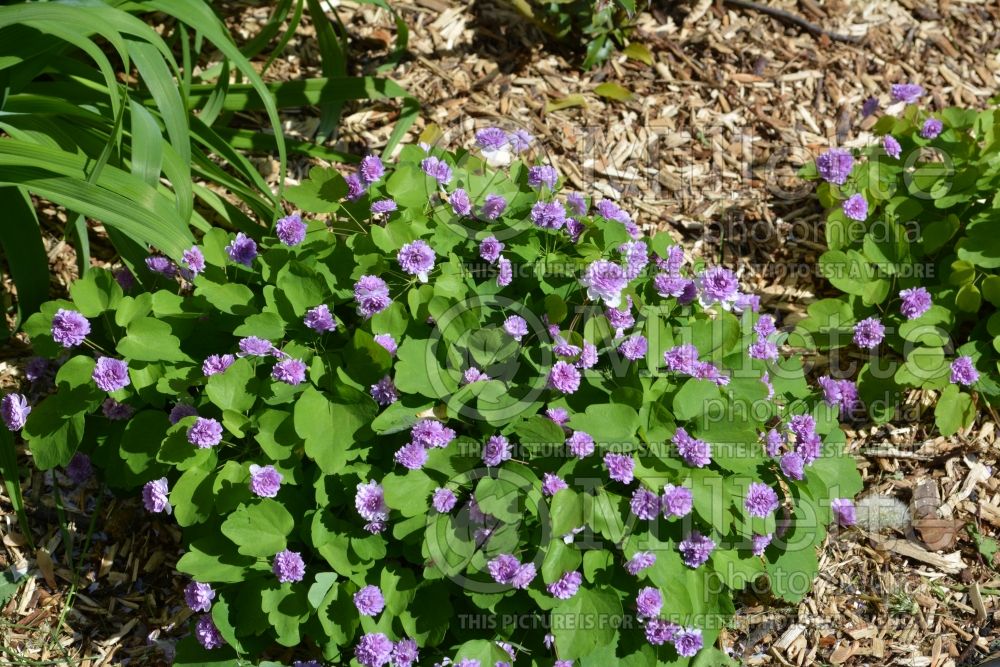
[0,186,49,323]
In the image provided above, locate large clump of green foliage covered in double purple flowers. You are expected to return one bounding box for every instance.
[5,128,860,667]
